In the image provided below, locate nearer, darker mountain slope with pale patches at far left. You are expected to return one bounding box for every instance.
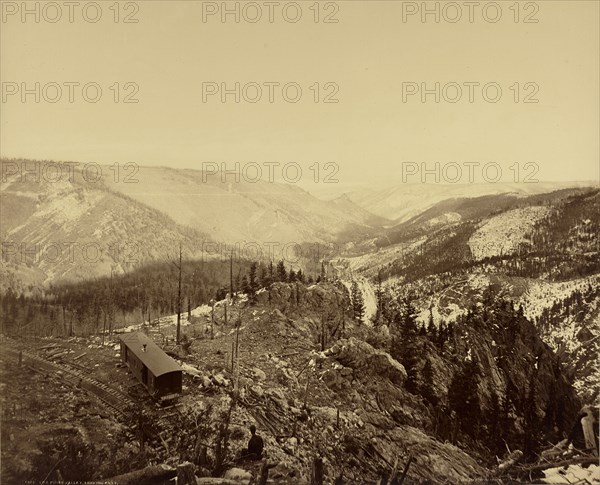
[0,163,209,289]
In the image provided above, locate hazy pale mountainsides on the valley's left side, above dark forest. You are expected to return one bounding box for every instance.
[0,160,384,286]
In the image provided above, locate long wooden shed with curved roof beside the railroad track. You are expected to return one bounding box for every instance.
[119,332,183,400]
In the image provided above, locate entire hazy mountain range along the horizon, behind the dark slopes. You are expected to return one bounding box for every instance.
[0,160,596,286]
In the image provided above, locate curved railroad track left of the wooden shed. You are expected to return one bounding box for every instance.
[3,349,135,418]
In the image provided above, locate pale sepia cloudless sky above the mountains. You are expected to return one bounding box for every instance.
[0,0,600,183]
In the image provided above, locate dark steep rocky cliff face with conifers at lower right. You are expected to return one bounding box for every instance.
[380,300,581,458]
